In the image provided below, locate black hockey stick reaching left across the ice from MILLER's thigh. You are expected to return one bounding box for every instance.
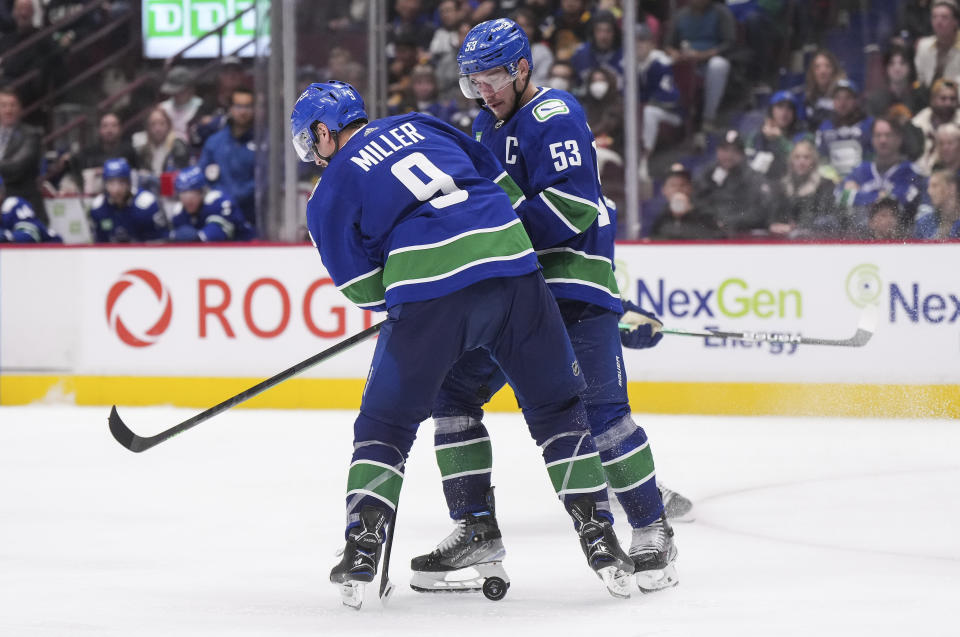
[110,321,385,453]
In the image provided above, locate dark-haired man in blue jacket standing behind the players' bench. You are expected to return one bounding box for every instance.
[199,88,257,224]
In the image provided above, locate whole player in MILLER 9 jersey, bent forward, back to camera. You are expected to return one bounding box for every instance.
[291,81,633,607]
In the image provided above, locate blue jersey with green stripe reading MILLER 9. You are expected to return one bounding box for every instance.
[307,113,537,310]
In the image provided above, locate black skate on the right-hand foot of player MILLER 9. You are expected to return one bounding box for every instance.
[570,498,634,599]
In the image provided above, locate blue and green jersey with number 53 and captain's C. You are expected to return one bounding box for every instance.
[473,88,623,313]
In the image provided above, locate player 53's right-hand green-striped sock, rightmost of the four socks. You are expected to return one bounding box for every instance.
[594,416,663,528]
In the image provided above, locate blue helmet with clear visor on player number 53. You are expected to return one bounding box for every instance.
[457,18,533,98]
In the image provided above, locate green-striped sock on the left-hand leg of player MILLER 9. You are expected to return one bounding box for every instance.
[344,440,404,536]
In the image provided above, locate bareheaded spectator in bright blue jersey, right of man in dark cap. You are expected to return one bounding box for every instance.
[841,117,926,234]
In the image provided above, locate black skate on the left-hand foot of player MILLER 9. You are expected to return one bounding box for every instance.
[330,506,387,610]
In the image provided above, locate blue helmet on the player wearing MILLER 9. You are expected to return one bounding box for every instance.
[290,80,368,163]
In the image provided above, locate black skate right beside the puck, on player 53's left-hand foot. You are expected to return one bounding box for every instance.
[410,489,510,600]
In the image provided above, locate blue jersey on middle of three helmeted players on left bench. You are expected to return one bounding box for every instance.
[90,190,169,243]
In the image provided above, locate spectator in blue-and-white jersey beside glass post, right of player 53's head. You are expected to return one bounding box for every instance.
[636,24,683,157]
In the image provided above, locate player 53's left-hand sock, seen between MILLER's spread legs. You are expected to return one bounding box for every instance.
[433,416,493,520]
